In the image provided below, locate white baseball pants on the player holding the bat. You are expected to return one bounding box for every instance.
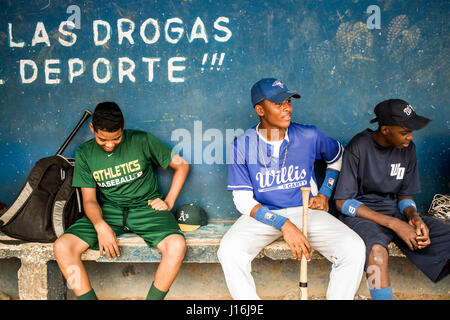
[217,207,366,300]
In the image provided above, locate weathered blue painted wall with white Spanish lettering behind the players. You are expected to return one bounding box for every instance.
[0,0,450,219]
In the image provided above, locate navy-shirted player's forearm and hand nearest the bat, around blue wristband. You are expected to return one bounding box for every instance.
[336,199,419,250]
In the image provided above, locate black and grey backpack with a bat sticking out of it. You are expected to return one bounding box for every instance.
[0,110,91,243]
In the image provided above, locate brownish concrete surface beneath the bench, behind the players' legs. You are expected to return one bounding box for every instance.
[0,257,450,300]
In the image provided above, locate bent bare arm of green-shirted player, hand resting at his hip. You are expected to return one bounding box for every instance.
[148,154,189,211]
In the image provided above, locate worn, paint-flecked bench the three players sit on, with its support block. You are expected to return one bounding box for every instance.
[0,221,404,300]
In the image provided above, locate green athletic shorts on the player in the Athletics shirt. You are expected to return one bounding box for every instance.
[65,204,184,250]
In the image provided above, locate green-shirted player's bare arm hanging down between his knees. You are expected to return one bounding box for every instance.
[81,188,120,259]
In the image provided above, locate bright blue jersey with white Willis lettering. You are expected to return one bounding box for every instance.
[228,122,343,210]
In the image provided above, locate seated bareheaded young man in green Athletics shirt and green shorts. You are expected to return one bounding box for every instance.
[54,102,189,299]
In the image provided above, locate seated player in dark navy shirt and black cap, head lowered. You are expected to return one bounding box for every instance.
[334,99,450,300]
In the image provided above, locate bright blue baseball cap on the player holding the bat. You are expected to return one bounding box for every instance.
[251,78,300,106]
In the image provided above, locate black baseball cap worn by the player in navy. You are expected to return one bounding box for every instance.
[370,99,431,130]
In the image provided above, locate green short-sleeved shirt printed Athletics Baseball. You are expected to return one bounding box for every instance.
[72,130,172,207]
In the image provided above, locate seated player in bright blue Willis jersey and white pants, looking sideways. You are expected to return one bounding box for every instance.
[218,78,365,300]
